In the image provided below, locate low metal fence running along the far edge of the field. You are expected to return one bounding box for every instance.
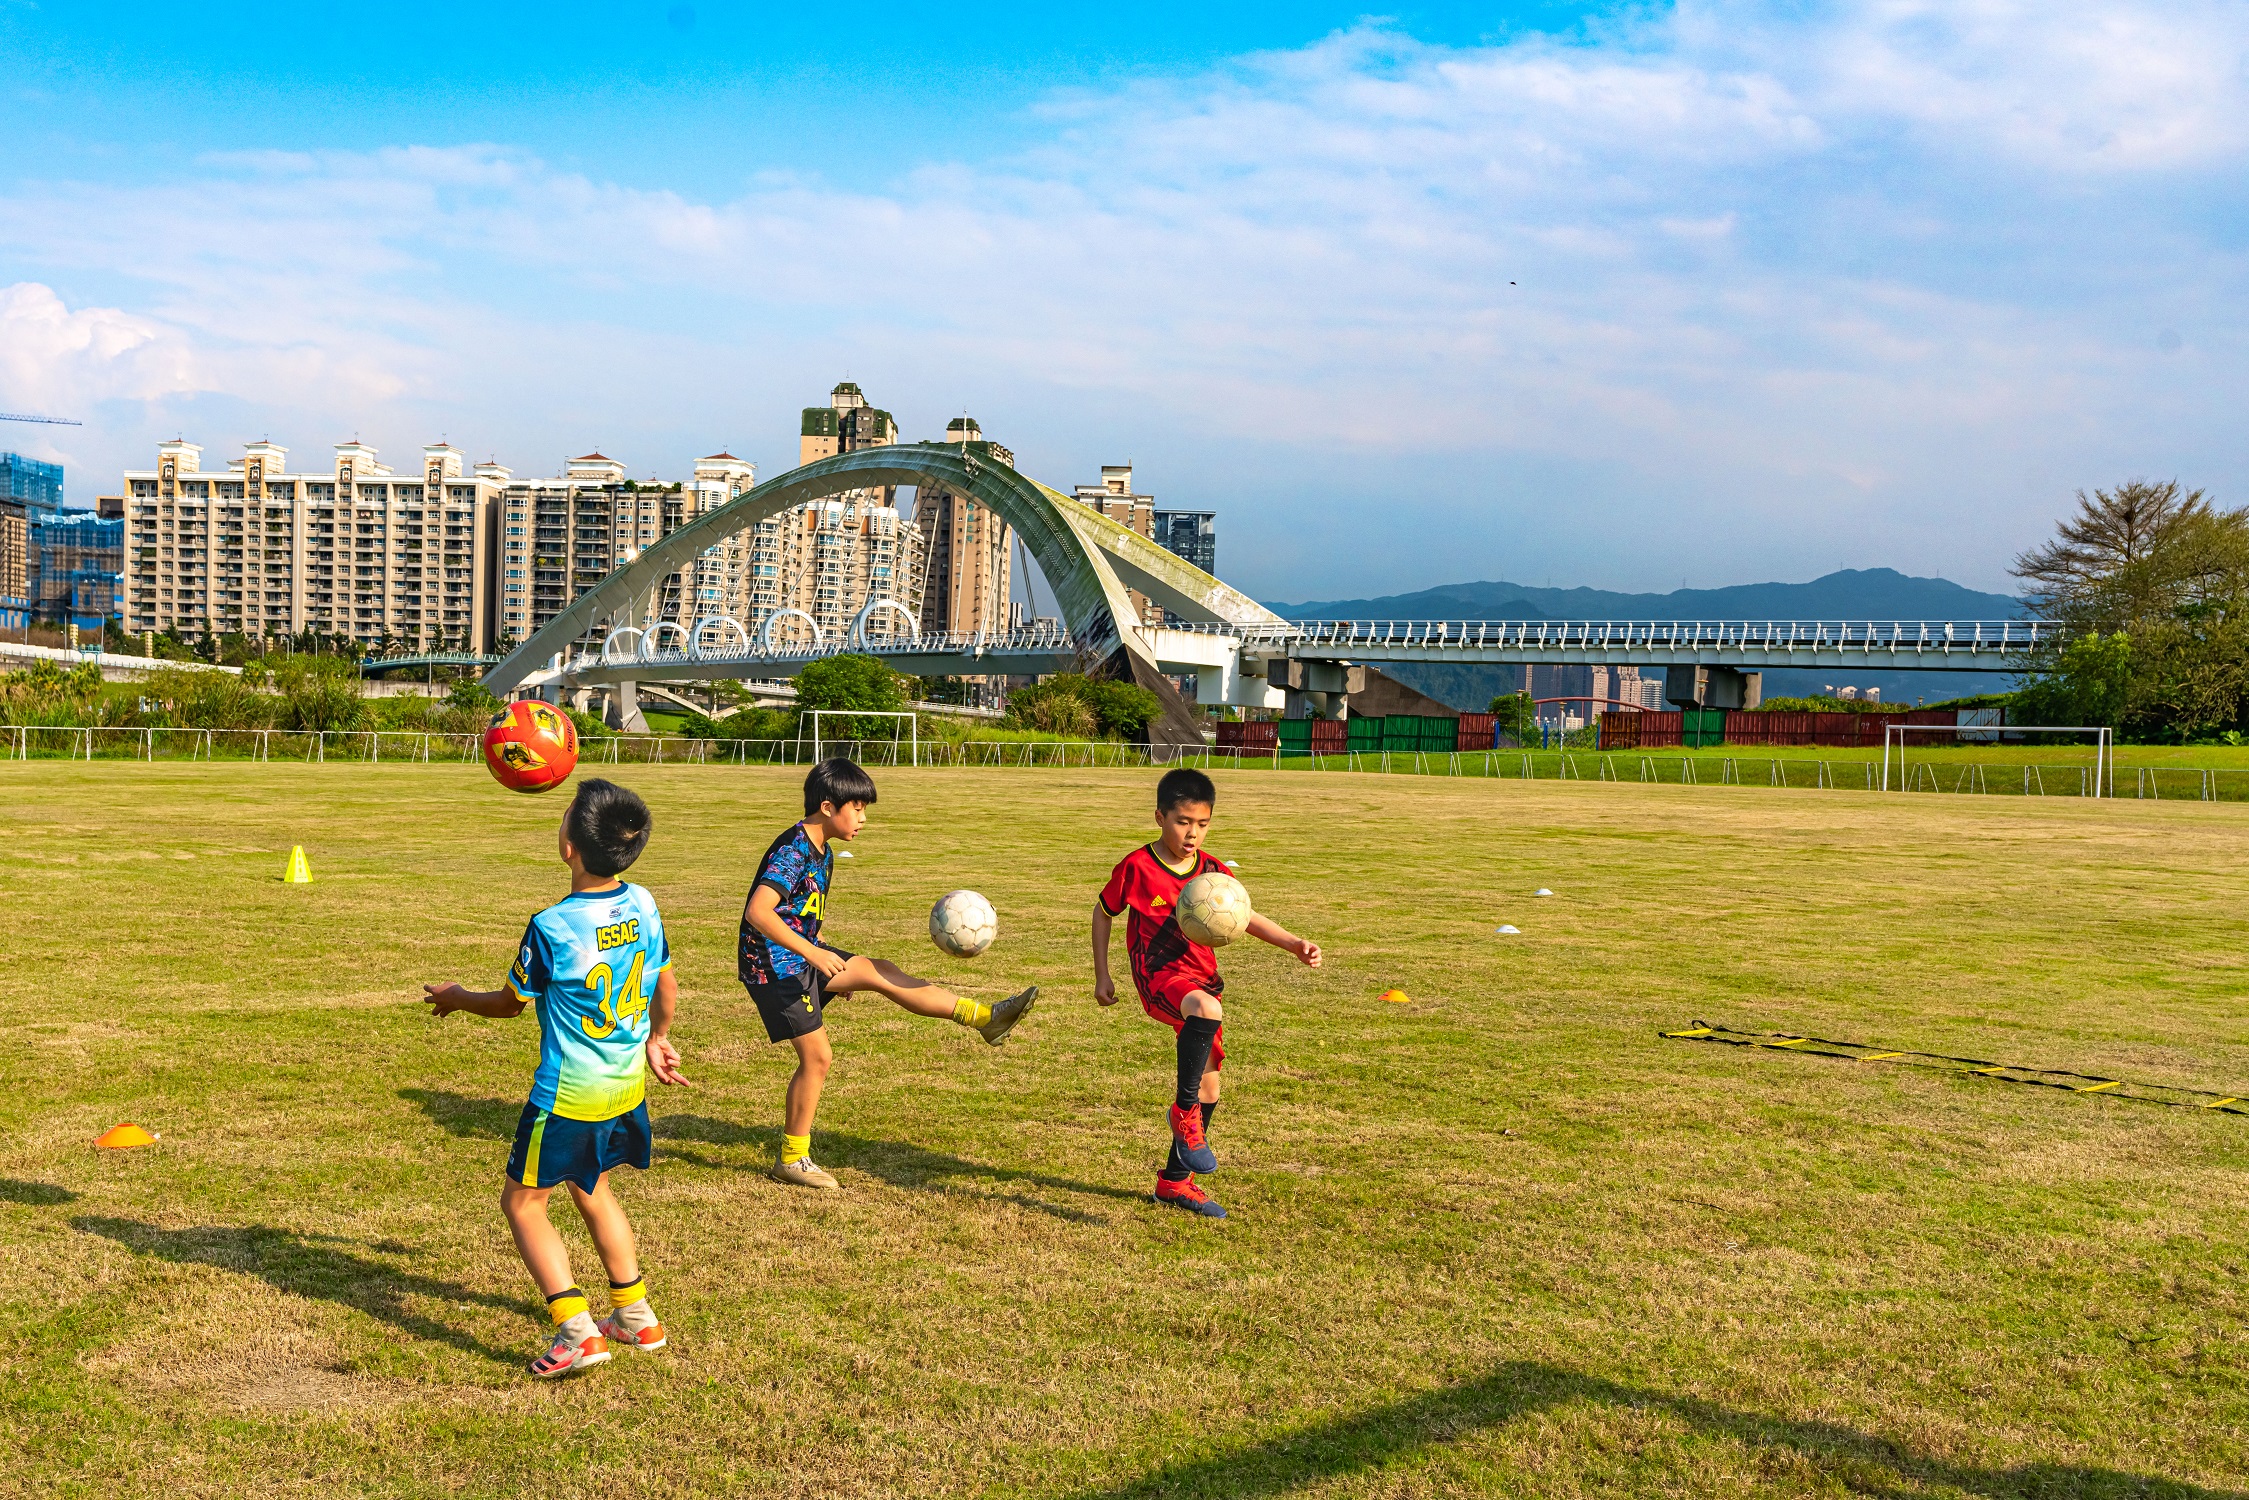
[0,724,2249,803]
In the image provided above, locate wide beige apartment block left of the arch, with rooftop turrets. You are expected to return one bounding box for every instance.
[124,441,499,652]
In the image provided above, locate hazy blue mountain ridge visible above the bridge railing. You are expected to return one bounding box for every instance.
[1266,567,2024,621]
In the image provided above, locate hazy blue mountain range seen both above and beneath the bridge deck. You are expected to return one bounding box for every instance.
[1266,567,2024,708]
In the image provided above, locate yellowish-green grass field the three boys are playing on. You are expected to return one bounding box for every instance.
[0,762,2249,1500]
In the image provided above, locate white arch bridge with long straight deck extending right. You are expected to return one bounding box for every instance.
[484,443,2053,744]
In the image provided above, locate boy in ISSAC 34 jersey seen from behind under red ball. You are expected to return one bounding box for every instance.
[423,780,686,1381]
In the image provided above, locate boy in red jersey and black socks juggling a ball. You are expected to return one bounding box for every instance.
[1093,767,1320,1219]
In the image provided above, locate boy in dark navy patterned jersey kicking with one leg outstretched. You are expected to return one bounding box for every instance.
[738,758,1039,1187]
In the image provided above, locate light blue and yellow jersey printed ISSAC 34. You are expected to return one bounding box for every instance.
[508,884,672,1120]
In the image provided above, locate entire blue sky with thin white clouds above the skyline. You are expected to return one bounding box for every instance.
[0,0,2249,598]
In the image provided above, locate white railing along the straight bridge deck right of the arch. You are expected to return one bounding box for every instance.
[1176,621,2053,657]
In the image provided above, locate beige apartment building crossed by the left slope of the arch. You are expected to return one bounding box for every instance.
[493,452,758,650]
